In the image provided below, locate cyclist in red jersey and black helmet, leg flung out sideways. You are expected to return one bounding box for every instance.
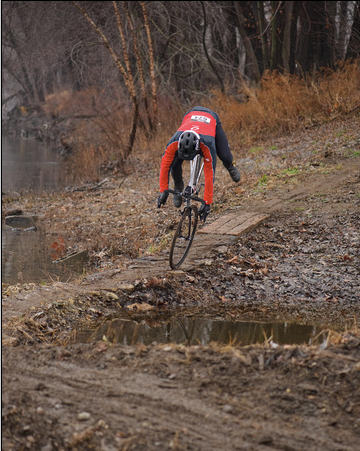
[158,106,240,221]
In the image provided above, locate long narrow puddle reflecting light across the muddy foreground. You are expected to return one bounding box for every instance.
[72,318,325,346]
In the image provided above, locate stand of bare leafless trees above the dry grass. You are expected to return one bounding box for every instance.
[2,1,360,127]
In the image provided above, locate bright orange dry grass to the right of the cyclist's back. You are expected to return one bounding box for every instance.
[208,60,360,146]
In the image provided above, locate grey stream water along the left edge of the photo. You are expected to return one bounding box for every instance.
[1,137,81,284]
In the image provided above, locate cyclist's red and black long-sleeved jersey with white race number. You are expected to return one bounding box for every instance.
[160,107,219,204]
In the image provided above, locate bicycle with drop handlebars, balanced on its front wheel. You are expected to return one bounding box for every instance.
[160,154,206,269]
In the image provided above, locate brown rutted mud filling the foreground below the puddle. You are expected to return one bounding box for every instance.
[2,335,360,451]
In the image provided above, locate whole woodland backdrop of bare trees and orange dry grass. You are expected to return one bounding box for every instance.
[2,1,360,180]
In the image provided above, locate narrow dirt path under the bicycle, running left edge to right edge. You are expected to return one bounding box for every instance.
[2,158,360,322]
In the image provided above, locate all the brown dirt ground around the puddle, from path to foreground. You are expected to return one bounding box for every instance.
[2,117,360,451]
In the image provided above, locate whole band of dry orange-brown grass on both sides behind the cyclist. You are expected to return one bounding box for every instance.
[44,59,360,181]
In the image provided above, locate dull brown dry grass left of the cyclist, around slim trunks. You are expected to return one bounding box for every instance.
[62,92,183,182]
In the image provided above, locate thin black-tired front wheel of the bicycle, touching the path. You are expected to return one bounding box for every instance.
[169,205,199,269]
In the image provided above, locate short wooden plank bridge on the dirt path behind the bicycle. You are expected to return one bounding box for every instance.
[198,211,268,236]
